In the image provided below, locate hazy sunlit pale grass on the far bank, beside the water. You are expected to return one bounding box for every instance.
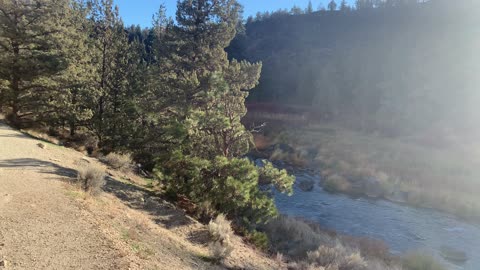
[291,123,480,218]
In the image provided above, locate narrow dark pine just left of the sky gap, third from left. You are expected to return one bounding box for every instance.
[89,0,134,148]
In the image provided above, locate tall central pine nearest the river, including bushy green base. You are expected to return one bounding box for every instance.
[157,0,293,225]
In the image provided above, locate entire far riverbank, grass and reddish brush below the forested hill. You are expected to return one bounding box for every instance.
[249,117,480,221]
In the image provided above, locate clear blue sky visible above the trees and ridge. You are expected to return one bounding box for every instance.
[114,0,353,27]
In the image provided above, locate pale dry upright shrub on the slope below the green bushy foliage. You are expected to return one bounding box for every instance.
[208,214,234,261]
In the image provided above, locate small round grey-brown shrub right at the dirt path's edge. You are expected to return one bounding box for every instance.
[77,164,105,195]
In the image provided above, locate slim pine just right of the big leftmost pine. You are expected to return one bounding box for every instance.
[54,1,99,136]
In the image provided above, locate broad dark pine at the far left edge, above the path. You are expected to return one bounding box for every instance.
[0,0,68,124]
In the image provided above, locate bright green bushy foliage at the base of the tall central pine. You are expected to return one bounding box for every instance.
[156,151,294,228]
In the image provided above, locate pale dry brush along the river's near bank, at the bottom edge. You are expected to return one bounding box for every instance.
[264,216,438,270]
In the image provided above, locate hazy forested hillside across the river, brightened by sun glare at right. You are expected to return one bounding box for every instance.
[228,0,480,133]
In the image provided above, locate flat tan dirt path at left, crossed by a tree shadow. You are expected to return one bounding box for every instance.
[0,123,128,269]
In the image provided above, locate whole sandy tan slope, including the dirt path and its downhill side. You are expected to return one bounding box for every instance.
[0,122,282,269]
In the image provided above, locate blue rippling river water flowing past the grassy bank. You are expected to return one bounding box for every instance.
[275,171,480,270]
